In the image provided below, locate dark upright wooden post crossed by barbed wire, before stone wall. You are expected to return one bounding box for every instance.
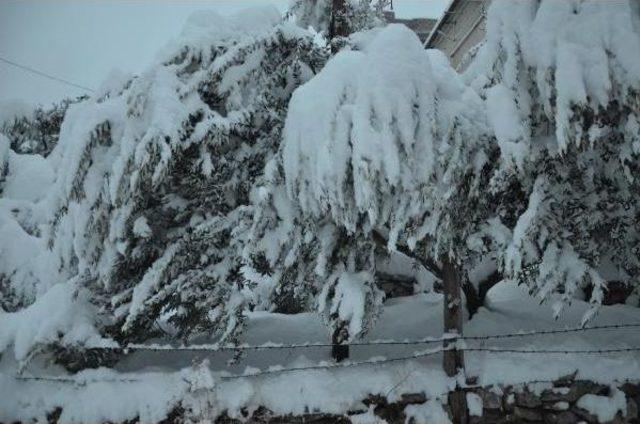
[442,257,468,424]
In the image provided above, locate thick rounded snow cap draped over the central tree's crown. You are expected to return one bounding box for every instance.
[283,25,485,235]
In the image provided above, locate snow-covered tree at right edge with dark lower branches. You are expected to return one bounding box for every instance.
[465,1,640,319]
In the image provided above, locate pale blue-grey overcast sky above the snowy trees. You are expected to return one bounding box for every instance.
[0,0,448,104]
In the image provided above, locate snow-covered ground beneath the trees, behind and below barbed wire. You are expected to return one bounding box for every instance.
[0,283,640,422]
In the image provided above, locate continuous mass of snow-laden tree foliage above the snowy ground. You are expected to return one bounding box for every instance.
[0,0,640,390]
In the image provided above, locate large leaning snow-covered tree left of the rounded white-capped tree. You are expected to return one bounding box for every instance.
[0,7,327,362]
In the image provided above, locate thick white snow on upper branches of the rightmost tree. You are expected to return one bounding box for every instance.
[464,0,640,153]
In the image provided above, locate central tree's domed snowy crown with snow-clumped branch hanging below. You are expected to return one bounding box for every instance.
[282,25,487,336]
